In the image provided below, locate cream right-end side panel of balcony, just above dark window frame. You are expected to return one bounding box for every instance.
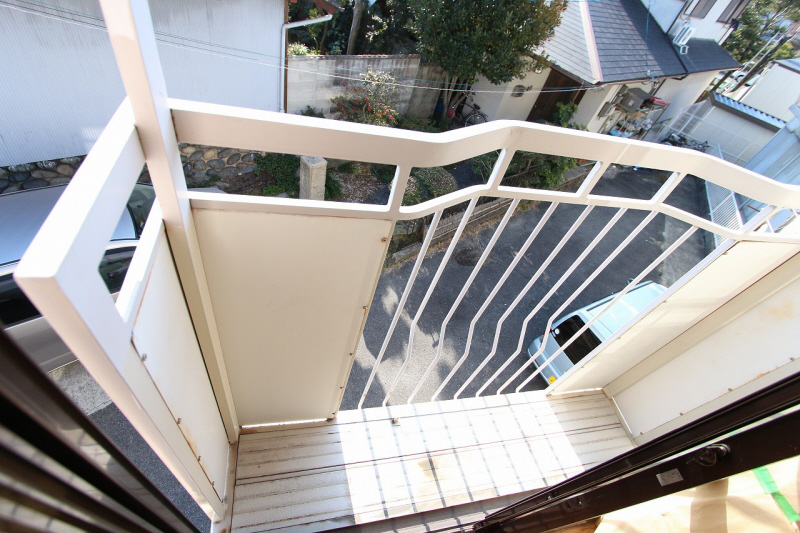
[614,251,800,442]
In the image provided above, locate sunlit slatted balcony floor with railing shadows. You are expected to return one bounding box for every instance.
[232,392,632,533]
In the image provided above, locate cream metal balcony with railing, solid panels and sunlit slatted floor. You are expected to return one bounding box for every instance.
[9,0,800,532]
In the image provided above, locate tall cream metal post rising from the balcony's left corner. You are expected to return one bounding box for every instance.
[100,0,239,443]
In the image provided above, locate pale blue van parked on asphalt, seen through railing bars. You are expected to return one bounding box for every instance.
[528,281,667,383]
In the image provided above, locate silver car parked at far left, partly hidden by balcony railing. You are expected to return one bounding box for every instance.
[0,184,156,372]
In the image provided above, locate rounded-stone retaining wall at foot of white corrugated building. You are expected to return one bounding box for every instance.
[0,143,263,194]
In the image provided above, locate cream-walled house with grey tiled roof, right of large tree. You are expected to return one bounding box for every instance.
[475,0,747,136]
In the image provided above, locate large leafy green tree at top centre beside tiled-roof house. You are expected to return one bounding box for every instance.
[409,0,568,108]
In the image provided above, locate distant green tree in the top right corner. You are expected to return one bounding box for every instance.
[724,0,800,63]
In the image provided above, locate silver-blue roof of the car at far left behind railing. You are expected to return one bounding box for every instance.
[0,185,136,265]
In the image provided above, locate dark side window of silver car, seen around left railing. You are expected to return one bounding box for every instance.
[0,247,136,326]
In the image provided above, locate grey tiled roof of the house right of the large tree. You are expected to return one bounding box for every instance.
[543,0,739,85]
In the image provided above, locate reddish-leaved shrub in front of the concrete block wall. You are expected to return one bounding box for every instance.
[331,69,399,127]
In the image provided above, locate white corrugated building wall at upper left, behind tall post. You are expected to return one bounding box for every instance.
[0,0,284,166]
